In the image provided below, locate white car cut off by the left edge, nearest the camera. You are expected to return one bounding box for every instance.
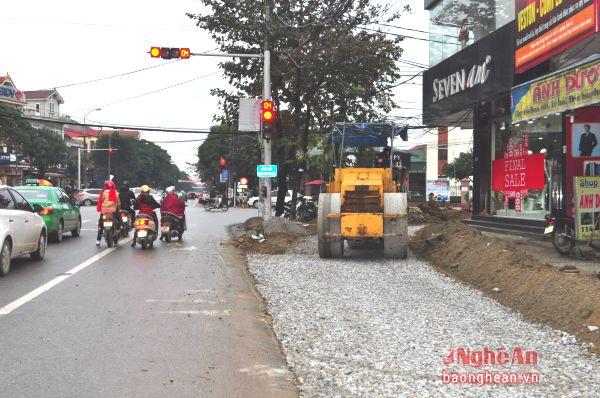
[0,185,48,276]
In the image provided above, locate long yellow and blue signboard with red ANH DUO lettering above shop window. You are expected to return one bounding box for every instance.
[511,56,600,122]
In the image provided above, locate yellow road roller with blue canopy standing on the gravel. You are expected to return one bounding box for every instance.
[317,123,408,258]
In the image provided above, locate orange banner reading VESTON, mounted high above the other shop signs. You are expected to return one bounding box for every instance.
[515,0,598,73]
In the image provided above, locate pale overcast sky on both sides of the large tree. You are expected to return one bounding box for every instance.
[0,0,428,177]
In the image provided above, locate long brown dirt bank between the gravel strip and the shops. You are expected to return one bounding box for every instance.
[410,220,600,353]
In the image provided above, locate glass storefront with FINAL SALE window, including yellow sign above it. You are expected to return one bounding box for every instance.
[506,55,600,219]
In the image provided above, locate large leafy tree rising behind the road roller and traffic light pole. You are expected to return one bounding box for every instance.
[188,0,402,214]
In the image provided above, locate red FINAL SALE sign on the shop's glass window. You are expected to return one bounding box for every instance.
[492,133,545,212]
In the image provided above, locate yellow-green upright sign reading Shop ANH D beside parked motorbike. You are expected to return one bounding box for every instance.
[573,177,600,240]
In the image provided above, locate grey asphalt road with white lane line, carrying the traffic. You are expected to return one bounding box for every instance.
[0,207,296,397]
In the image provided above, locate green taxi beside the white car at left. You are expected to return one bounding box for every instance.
[15,185,81,242]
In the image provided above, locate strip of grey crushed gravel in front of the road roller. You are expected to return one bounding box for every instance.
[248,229,600,397]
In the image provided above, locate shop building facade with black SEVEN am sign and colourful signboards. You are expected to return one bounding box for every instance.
[423,0,600,233]
